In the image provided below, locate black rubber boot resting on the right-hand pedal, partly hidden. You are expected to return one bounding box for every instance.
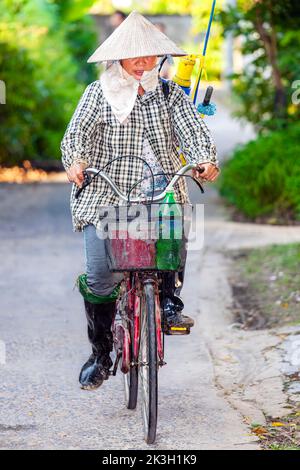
[162,272,194,328]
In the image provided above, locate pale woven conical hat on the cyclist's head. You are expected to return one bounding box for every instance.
[88,11,187,62]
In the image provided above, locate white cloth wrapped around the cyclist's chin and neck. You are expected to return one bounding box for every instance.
[100,61,159,123]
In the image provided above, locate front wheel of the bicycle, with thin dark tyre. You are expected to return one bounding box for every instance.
[139,283,158,444]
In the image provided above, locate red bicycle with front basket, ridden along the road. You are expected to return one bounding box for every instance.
[76,162,203,444]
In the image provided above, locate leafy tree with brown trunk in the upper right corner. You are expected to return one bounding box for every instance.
[220,0,300,131]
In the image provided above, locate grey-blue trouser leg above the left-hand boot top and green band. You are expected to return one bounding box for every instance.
[83,225,123,296]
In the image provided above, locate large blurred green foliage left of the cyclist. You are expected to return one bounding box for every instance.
[0,0,96,165]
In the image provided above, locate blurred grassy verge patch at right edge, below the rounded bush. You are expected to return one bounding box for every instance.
[231,244,300,328]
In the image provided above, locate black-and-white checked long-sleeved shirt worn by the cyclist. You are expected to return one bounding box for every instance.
[61,79,218,231]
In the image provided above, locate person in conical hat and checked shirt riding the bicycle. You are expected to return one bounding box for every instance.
[61,11,218,389]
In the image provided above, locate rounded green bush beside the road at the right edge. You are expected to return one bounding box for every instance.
[220,123,300,220]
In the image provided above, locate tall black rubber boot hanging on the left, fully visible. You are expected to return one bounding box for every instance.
[79,300,115,390]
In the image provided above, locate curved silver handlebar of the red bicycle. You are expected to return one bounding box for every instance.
[75,163,204,203]
